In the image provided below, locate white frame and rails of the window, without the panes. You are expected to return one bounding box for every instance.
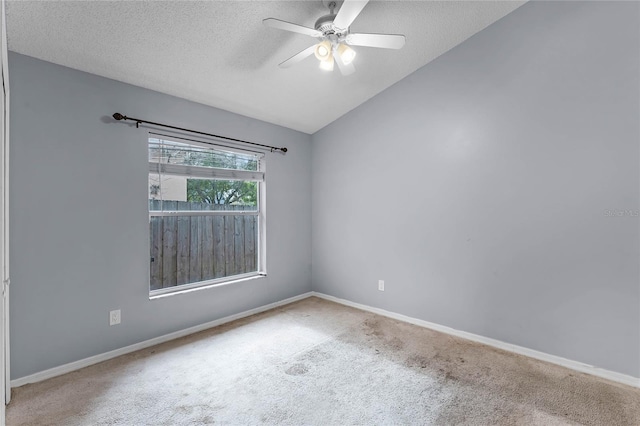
[147,133,267,299]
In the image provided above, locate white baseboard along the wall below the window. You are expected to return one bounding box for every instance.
[11,292,313,388]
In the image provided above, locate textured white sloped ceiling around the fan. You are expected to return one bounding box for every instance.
[7,0,524,133]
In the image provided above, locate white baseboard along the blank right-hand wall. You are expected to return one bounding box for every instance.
[311,291,640,388]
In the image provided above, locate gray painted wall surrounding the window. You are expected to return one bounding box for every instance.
[9,53,311,379]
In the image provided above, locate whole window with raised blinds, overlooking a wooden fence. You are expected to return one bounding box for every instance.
[149,137,265,296]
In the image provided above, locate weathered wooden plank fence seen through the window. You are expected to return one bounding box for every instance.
[149,200,258,290]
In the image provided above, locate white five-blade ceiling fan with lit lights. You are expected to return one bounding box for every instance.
[262,0,405,75]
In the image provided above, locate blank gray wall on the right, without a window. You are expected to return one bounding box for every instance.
[312,2,640,377]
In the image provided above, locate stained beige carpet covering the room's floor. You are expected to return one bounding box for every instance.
[7,298,640,425]
